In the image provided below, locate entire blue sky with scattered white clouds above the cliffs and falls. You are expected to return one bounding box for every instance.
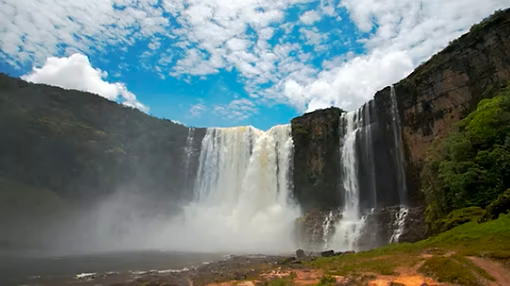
[0,0,510,129]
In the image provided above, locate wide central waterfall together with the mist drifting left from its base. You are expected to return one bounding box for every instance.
[0,125,301,255]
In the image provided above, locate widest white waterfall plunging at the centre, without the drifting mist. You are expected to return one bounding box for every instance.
[163,125,300,253]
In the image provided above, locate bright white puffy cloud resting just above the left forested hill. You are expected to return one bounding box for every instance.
[21,54,149,112]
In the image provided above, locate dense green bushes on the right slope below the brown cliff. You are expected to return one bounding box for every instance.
[421,88,510,233]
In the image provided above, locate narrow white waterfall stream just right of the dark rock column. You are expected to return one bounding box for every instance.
[332,112,365,251]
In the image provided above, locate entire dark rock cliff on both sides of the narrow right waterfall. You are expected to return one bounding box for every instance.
[292,9,510,245]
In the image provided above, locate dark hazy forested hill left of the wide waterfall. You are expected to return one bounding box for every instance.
[0,74,203,209]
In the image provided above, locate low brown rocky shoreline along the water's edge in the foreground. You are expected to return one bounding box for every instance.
[65,249,353,286]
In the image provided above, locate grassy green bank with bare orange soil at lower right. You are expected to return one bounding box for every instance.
[308,214,510,285]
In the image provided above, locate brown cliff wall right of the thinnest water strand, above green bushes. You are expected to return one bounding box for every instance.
[375,7,510,204]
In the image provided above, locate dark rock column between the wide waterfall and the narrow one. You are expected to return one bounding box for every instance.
[291,108,343,211]
